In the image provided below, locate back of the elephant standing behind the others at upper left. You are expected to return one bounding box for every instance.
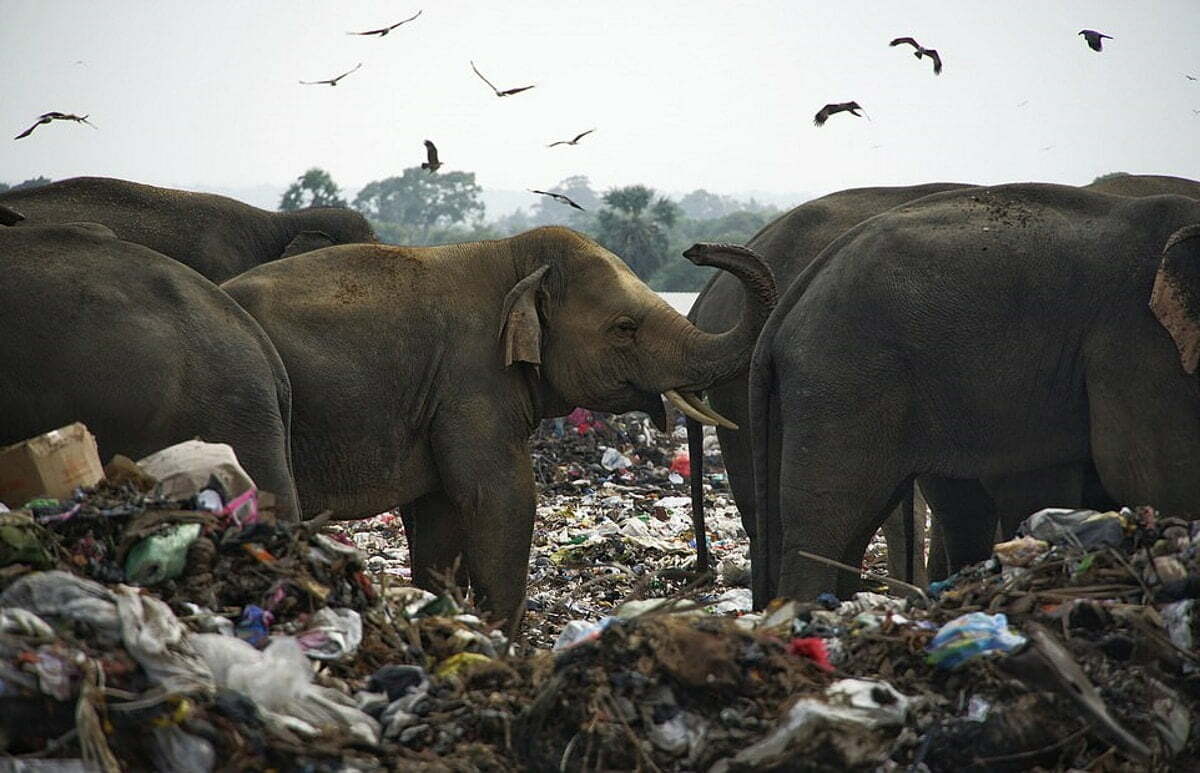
[0,178,376,283]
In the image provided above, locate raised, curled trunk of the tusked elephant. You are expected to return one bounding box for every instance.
[667,242,778,396]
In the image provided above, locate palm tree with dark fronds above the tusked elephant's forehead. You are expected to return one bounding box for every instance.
[596,185,679,281]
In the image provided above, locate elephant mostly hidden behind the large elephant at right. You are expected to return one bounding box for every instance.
[688,182,968,582]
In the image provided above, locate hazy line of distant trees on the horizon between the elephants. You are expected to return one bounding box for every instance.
[280,167,779,292]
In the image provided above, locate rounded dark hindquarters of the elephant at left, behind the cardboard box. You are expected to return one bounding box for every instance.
[0,223,299,520]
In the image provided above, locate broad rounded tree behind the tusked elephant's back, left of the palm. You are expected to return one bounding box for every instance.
[354,167,484,244]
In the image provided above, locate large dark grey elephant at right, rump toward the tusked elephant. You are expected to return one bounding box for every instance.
[750,184,1200,598]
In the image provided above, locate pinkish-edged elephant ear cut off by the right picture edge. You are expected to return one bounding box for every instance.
[1150,224,1200,373]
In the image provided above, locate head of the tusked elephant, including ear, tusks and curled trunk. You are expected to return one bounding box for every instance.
[500,228,775,429]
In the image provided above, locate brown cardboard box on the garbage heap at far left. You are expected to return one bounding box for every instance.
[0,421,104,509]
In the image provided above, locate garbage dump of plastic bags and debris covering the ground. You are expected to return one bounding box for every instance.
[0,415,1200,772]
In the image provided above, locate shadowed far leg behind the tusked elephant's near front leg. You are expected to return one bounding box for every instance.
[410,491,469,593]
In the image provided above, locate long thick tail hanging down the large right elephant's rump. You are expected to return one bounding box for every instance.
[750,337,782,610]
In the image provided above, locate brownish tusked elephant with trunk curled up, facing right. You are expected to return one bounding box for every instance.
[222,227,774,625]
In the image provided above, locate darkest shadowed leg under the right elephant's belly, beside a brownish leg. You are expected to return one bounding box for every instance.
[920,475,997,580]
